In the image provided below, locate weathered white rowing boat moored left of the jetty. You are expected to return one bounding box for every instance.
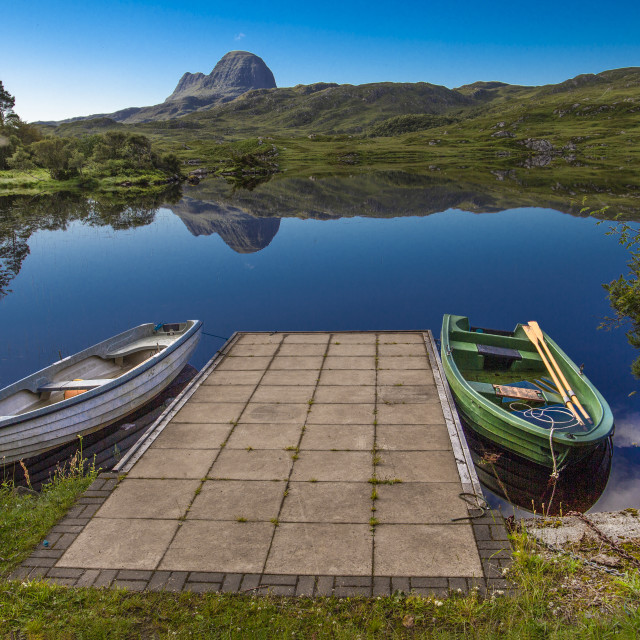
[0,320,202,464]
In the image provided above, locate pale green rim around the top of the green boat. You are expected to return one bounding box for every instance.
[441,314,613,449]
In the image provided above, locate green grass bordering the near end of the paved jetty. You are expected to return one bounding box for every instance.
[0,461,640,640]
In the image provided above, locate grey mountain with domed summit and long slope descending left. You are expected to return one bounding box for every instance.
[50,51,276,124]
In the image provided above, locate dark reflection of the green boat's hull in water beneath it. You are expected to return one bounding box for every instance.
[463,424,613,515]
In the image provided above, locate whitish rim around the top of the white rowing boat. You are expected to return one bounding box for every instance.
[0,320,202,430]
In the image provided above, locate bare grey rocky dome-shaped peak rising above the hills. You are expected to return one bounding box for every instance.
[165,51,276,103]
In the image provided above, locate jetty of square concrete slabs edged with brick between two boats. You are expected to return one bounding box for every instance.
[14,331,510,596]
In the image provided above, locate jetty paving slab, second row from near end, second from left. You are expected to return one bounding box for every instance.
[187,480,286,522]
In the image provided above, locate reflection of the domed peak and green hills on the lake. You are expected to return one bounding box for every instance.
[168,171,640,253]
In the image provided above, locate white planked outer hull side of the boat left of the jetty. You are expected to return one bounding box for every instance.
[0,322,202,463]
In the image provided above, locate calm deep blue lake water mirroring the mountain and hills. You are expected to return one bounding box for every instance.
[0,176,640,510]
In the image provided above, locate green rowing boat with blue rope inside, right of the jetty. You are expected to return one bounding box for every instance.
[441,314,613,467]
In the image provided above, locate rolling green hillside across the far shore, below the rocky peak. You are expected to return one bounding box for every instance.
[3,67,640,208]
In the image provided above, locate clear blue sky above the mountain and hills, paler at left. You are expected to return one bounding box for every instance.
[0,0,640,121]
